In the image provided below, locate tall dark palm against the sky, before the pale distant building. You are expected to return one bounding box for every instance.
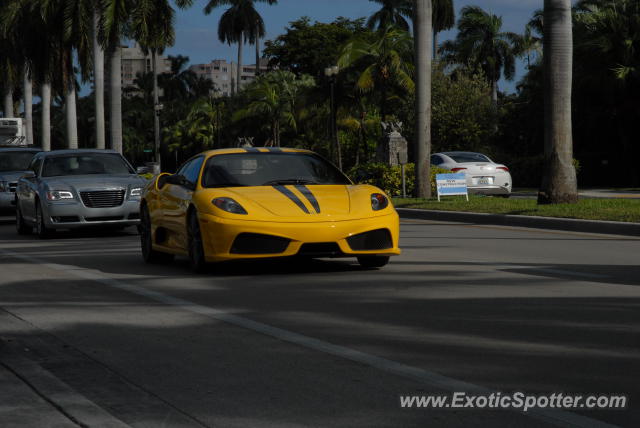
[204,0,277,93]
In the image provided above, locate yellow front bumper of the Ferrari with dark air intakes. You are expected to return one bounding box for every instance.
[199,211,400,262]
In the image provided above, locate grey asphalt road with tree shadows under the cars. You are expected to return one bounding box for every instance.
[0,220,640,427]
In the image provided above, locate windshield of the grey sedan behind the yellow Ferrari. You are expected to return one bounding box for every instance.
[42,153,133,177]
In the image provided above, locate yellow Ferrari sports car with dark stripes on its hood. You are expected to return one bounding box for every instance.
[140,148,400,271]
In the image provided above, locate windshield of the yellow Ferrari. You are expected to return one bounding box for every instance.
[202,153,351,187]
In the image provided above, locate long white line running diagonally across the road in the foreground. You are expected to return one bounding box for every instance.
[0,249,616,428]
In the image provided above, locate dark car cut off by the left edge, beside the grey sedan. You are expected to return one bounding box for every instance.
[0,147,42,209]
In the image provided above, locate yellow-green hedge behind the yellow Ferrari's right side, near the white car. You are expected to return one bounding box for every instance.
[348,162,451,196]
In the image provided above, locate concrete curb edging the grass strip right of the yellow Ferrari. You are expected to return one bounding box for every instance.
[396,208,640,236]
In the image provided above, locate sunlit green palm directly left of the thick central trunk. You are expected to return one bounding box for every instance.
[338,23,416,122]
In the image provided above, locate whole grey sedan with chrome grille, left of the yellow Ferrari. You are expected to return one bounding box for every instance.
[16,150,146,238]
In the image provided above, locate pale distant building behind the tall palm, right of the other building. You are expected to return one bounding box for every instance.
[189,59,269,96]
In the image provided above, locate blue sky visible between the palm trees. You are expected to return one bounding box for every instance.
[166,0,543,92]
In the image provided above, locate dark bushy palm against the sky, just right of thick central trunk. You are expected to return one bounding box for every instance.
[441,6,519,105]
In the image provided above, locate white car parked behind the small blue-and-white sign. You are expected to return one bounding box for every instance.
[431,152,512,198]
